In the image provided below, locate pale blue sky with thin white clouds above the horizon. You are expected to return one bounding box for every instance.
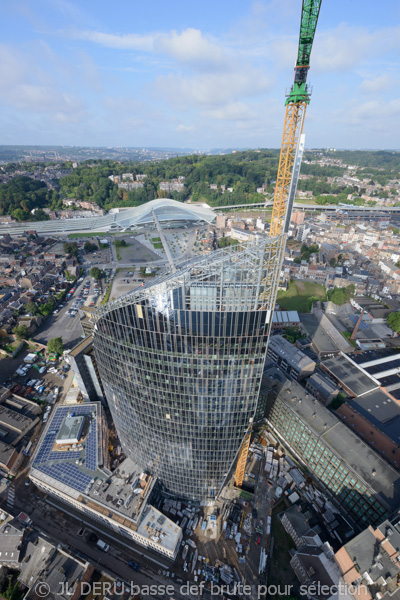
[0,0,400,150]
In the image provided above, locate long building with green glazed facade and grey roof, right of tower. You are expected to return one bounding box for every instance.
[267,372,400,527]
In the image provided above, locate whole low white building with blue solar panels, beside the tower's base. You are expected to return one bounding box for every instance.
[29,402,182,559]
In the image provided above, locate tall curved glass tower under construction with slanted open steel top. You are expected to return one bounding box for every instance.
[94,238,282,503]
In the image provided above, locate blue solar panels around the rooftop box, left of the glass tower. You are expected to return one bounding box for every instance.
[33,405,98,492]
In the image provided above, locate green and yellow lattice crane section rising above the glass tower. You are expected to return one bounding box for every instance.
[270,0,322,237]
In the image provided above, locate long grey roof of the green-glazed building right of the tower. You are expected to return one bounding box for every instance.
[278,381,400,511]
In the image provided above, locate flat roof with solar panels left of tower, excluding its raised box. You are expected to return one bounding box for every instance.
[31,402,181,550]
